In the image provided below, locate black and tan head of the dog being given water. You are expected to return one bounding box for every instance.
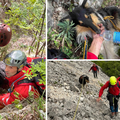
[69,0,104,34]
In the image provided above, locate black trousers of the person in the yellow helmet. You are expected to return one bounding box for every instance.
[107,93,119,112]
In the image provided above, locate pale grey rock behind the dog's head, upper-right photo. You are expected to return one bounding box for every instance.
[47,0,103,29]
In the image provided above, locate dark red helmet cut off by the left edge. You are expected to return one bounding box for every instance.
[0,23,12,47]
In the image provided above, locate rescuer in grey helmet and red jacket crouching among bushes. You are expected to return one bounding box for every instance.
[0,50,45,109]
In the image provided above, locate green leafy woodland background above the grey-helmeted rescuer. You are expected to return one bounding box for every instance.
[0,0,46,60]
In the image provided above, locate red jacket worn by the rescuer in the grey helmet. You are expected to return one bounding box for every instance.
[0,57,45,105]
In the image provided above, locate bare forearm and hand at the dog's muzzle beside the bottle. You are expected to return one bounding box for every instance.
[88,24,104,57]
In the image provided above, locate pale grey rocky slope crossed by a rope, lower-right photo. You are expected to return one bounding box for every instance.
[47,61,120,120]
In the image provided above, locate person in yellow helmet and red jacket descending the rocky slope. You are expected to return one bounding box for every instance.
[97,76,120,118]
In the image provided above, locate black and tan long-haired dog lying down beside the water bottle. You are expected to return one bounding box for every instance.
[61,0,120,59]
